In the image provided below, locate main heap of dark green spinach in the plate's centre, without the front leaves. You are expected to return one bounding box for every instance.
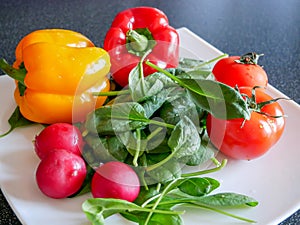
[84,54,249,185]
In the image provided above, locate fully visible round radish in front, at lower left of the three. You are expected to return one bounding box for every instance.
[36,149,86,198]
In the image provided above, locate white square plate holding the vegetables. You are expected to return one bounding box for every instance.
[0,28,300,225]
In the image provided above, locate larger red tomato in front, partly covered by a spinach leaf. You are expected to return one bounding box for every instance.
[207,87,285,160]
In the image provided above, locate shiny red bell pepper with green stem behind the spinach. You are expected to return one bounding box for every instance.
[103,7,179,87]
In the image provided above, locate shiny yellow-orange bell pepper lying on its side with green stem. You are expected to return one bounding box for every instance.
[0,29,110,124]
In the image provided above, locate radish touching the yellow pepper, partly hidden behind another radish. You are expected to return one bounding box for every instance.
[34,123,83,159]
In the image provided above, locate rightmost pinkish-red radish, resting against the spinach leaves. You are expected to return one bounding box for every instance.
[91,161,140,202]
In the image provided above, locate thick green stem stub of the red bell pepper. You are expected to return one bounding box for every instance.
[126,30,148,52]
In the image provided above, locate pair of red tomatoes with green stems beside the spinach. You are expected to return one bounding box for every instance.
[207,53,285,160]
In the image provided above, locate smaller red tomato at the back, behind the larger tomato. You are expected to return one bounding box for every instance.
[212,53,268,87]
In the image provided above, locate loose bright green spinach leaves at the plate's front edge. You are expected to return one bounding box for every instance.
[82,171,258,225]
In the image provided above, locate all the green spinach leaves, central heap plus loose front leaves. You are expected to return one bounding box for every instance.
[83,55,257,225]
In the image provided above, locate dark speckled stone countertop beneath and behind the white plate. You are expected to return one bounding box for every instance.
[0,0,300,225]
